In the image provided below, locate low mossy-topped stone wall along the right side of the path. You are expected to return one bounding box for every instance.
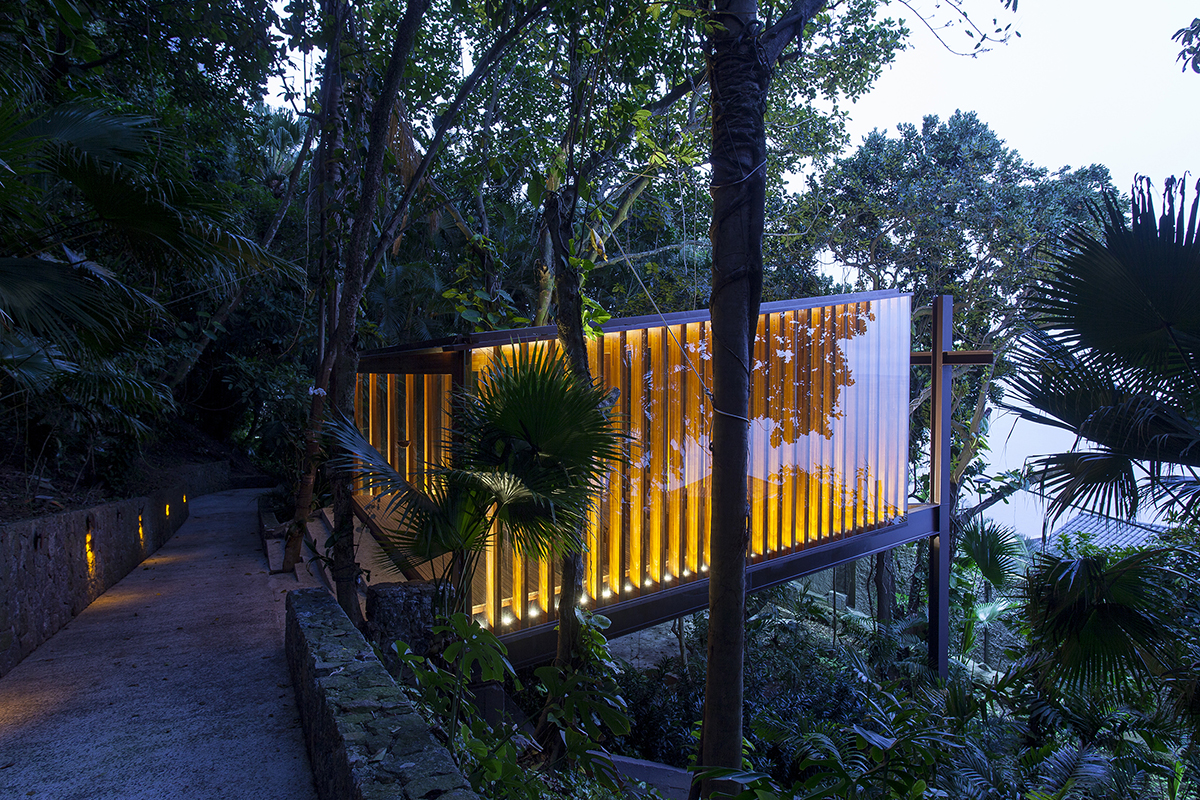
[286,589,478,800]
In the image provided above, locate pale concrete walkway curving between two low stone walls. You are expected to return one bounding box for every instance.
[0,489,316,800]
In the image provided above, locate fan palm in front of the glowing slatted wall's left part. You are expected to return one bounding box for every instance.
[330,347,625,610]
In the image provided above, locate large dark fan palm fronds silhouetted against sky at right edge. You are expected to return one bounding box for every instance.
[1009,179,1200,517]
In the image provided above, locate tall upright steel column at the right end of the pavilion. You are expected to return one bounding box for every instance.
[929,295,954,678]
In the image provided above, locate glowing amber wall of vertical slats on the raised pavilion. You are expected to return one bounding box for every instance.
[356,293,911,633]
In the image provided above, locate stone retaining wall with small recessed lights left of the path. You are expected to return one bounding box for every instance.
[0,462,229,675]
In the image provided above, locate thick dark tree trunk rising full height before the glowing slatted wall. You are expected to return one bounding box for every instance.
[700,0,770,796]
